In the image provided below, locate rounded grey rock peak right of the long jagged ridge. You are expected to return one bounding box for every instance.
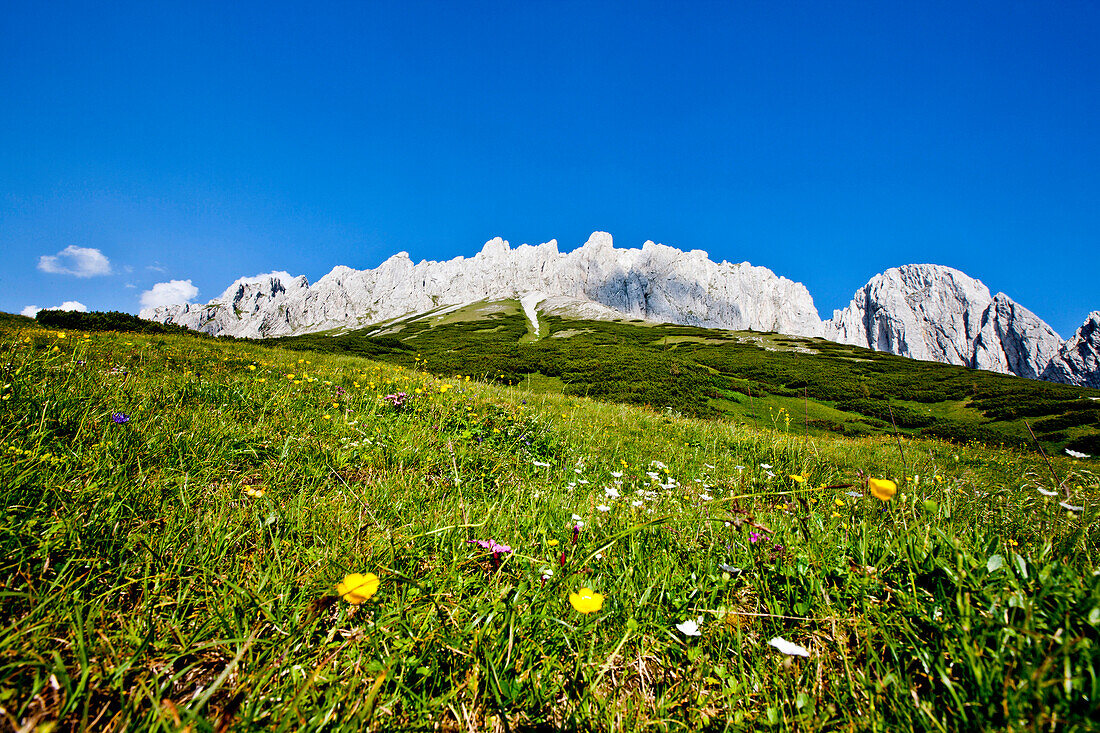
[825,264,1062,379]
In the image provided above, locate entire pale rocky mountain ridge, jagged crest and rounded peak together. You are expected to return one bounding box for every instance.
[140,231,1100,385]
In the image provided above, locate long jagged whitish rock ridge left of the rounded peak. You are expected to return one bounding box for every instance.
[141,232,823,337]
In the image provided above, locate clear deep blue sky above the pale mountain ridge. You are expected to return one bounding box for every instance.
[0,0,1100,337]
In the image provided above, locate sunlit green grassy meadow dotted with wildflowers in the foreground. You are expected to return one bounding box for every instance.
[0,318,1100,731]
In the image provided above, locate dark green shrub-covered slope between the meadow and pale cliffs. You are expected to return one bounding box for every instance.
[268,299,1100,455]
